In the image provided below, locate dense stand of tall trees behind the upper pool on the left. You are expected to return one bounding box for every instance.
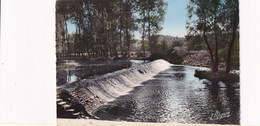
[56,0,167,59]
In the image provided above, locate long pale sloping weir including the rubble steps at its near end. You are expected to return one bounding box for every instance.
[57,59,171,118]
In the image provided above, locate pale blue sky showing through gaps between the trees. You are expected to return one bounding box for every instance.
[68,0,189,39]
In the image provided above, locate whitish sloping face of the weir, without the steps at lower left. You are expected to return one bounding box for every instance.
[61,60,172,110]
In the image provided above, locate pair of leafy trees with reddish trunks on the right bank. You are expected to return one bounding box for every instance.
[187,0,239,73]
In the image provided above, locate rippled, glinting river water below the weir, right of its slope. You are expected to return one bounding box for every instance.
[93,66,240,124]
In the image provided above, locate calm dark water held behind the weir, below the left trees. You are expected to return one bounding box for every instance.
[56,60,133,86]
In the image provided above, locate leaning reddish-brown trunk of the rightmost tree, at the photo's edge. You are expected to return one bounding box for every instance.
[226,22,238,73]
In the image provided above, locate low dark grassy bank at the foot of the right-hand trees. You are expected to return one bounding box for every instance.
[194,70,239,83]
